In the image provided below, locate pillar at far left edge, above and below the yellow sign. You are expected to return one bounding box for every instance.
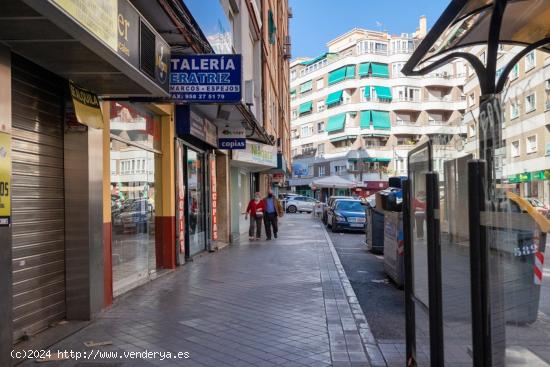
[0,45,13,366]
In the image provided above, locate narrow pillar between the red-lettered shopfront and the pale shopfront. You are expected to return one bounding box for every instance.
[215,154,231,249]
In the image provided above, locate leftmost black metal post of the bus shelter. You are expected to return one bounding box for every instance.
[401,178,416,367]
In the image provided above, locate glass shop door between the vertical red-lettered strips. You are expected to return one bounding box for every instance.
[186,148,206,257]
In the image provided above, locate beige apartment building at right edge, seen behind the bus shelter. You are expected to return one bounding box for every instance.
[464,46,550,205]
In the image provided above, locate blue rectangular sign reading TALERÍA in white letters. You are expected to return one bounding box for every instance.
[170,54,242,103]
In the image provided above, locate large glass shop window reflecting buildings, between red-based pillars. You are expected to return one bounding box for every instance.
[109,102,162,296]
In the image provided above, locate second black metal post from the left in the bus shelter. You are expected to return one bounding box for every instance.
[426,172,444,367]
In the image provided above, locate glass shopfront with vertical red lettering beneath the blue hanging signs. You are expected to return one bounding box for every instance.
[175,105,217,264]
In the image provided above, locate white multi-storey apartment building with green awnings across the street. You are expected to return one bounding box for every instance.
[290,17,466,196]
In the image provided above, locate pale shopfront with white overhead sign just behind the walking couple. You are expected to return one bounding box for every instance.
[231,140,277,241]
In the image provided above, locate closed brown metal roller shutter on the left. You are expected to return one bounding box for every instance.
[12,56,65,340]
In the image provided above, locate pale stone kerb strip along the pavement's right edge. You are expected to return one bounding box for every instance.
[322,225,387,367]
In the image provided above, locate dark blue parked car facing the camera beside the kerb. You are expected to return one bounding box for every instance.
[327,199,366,232]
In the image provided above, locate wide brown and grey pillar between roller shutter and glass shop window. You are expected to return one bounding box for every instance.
[64,119,104,320]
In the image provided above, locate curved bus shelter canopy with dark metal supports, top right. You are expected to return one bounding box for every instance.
[402,0,550,94]
